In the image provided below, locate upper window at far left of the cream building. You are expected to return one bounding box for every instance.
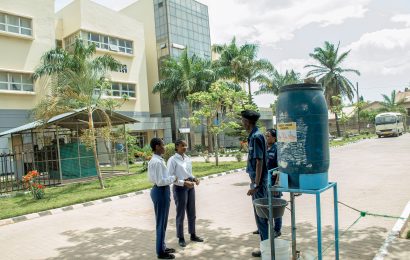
[0,12,33,36]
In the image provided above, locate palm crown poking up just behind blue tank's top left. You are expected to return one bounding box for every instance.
[255,69,301,95]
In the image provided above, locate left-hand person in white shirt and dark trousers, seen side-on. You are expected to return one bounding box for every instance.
[148,138,178,259]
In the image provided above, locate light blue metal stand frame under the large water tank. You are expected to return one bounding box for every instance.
[268,178,339,260]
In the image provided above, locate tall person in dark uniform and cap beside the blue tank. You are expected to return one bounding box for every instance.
[241,110,269,257]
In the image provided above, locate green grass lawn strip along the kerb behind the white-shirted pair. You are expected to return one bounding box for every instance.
[0,162,246,219]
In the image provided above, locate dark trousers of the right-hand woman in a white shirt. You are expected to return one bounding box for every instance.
[173,185,196,238]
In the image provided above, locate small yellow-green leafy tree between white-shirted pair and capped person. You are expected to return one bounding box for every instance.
[187,80,255,166]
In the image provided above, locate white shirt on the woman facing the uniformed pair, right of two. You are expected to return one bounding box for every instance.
[167,153,194,186]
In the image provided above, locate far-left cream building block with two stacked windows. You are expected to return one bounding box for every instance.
[0,0,55,153]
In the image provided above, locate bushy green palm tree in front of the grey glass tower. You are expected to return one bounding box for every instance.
[153,49,215,148]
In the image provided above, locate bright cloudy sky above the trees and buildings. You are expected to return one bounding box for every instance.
[56,0,410,107]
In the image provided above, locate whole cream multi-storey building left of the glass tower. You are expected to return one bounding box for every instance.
[0,0,171,152]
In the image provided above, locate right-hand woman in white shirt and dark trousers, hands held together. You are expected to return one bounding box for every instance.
[167,139,204,247]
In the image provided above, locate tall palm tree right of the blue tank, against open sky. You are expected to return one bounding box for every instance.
[305,41,360,137]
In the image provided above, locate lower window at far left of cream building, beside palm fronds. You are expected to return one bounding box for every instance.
[0,71,34,92]
